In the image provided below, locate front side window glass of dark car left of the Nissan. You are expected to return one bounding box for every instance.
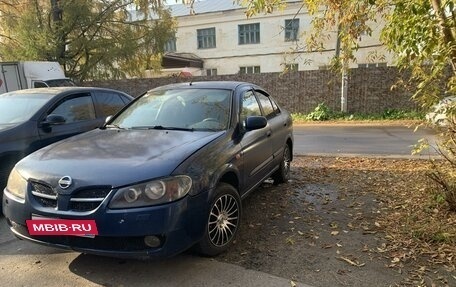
[48,95,95,124]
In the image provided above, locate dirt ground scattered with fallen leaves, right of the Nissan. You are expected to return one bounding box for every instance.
[217,157,456,286]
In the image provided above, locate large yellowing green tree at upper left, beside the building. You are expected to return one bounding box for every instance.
[0,0,176,81]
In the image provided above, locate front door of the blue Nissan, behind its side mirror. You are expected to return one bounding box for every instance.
[240,90,273,195]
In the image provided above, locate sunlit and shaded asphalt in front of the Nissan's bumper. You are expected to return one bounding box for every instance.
[0,216,309,287]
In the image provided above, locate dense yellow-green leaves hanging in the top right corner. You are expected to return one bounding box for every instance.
[382,0,456,108]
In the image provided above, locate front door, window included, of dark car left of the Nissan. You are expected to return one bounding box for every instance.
[38,93,99,150]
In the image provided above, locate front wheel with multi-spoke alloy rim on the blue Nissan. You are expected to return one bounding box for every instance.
[195,183,242,256]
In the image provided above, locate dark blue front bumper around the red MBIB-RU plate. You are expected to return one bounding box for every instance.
[3,189,209,259]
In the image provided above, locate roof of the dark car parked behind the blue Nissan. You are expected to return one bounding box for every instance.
[0,87,133,99]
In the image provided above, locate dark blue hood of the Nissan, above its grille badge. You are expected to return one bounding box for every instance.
[17,129,224,188]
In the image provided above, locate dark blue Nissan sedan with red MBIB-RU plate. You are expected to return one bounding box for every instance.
[2,81,293,258]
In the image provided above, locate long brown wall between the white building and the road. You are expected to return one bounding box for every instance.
[84,67,418,113]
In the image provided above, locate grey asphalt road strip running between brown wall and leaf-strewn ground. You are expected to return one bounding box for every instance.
[293,124,436,158]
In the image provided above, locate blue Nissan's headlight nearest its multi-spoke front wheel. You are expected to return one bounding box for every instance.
[109,175,192,208]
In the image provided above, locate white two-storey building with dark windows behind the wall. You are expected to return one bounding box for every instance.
[141,0,391,76]
